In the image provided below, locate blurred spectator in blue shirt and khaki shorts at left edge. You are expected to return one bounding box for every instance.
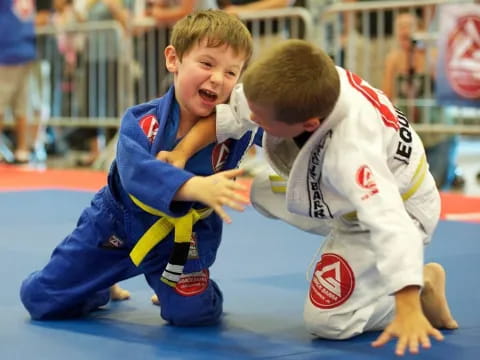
[0,0,36,163]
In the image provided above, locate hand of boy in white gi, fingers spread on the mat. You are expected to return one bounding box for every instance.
[372,288,443,356]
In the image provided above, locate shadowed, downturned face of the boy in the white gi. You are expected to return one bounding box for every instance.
[248,100,320,139]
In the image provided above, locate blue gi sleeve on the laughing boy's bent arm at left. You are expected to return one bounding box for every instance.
[116,104,194,217]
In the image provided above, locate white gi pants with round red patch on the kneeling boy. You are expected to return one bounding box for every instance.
[251,174,440,339]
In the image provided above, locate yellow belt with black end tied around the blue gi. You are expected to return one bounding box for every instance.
[130,195,213,286]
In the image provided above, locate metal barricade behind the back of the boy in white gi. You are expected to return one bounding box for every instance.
[307,0,480,135]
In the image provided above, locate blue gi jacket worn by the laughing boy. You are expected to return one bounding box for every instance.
[108,87,261,272]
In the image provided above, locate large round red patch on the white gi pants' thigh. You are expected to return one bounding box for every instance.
[309,253,355,309]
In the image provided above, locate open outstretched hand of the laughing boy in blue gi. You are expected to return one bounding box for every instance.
[175,169,249,223]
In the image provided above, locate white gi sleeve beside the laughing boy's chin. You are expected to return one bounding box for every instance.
[216,84,258,143]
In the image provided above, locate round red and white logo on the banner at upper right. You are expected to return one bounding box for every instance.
[445,14,480,99]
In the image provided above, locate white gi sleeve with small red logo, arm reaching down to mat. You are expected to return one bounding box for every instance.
[324,128,423,294]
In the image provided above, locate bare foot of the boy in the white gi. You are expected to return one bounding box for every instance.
[421,263,458,329]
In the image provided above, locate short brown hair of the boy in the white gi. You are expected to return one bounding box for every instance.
[243,40,340,124]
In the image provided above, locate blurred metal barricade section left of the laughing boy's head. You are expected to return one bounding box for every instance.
[37,21,130,128]
